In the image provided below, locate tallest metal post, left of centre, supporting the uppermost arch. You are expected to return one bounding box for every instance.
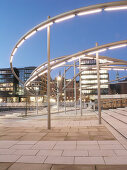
[47,16,51,129]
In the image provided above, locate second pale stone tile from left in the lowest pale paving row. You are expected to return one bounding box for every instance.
[16,156,46,163]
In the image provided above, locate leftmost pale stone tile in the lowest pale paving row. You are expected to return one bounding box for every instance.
[0,154,20,162]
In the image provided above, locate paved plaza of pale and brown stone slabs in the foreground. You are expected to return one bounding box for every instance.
[0,109,127,170]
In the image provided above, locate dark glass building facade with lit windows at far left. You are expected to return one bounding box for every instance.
[0,67,36,102]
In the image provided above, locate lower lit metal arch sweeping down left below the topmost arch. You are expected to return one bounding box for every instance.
[24,40,127,87]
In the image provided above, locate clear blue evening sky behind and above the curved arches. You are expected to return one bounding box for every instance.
[0,0,127,72]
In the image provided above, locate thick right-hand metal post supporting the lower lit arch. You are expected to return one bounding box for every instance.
[96,43,101,124]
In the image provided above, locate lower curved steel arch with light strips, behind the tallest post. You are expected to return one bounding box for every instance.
[24,40,127,86]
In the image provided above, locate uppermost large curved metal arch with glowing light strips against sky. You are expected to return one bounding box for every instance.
[10,1,127,85]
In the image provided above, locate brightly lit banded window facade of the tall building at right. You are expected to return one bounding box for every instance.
[81,59,109,95]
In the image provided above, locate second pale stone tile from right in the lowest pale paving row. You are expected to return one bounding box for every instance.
[75,157,105,165]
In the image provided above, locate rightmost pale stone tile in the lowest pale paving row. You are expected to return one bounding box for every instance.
[104,156,127,165]
